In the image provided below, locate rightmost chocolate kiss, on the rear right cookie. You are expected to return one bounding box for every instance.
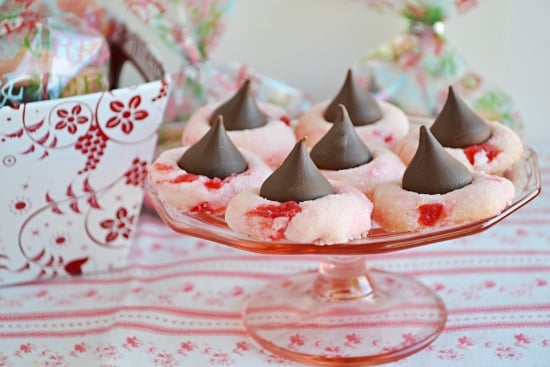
[430,87,491,148]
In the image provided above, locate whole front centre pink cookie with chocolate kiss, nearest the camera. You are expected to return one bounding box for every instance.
[225,140,372,245]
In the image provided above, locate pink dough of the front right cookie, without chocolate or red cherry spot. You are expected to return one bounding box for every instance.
[372,172,515,232]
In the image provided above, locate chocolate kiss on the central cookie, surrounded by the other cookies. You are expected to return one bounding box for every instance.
[310,105,372,171]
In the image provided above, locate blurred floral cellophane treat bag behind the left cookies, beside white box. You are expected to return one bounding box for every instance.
[101,0,310,149]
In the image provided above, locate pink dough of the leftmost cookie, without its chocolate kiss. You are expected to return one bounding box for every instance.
[149,147,271,215]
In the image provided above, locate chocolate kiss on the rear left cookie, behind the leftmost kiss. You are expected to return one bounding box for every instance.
[210,79,267,131]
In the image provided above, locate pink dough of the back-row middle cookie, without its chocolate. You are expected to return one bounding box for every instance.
[294,100,409,150]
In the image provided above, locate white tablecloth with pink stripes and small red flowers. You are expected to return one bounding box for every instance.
[0,145,550,367]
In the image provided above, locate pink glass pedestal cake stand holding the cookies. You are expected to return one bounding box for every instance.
[149,149,541,366]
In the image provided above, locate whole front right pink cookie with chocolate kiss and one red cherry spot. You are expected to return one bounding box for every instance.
[373,126,515,232]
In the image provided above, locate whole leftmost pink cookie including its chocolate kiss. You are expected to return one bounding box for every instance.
[149,119,271,215]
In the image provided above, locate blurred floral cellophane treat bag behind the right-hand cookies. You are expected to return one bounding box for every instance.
[354,0,523,131]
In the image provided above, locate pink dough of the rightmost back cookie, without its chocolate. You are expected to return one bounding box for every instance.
[395,121,523,175]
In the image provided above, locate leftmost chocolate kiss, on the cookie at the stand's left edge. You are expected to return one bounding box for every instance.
[178,116,248,179]
